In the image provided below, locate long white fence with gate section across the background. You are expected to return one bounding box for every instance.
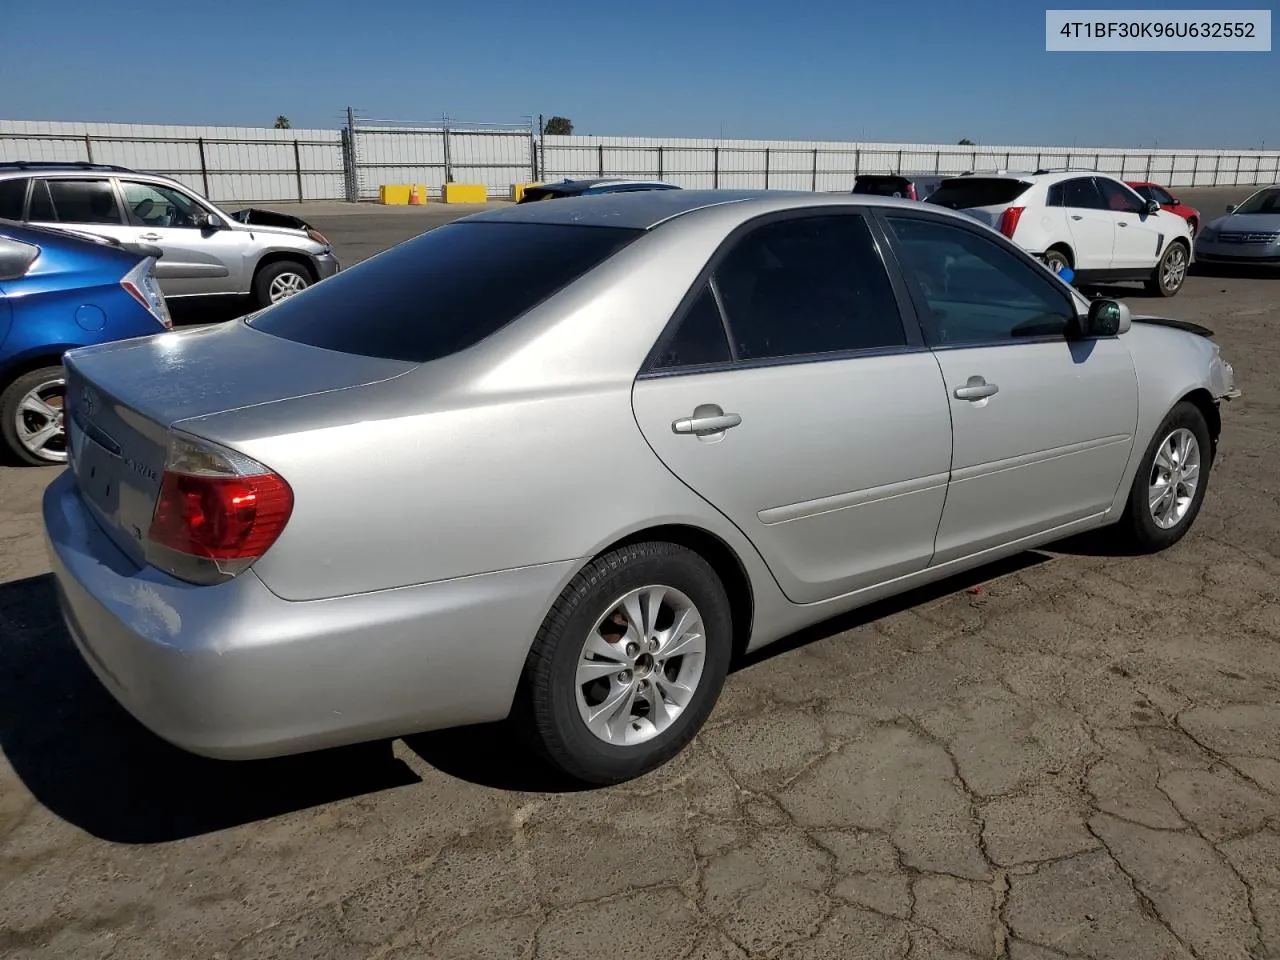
[0,117,1280,202]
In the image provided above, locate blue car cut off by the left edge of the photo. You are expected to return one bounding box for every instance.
[0,220,173,466]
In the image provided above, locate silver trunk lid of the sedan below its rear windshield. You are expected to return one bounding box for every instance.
[64,320,416,566]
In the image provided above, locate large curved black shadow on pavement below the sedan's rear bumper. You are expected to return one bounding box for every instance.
[0,575,420,844]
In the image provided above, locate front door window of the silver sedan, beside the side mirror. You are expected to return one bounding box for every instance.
[890,218,1075,346]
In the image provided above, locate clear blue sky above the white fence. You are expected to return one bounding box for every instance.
[0,0,1280,147]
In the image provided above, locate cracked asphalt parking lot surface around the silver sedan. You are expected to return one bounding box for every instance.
[0,191,1280,960]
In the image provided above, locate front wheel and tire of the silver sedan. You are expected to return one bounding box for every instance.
[1119,401,1213,553]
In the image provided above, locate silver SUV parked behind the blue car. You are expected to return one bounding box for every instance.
[0,161,338,307]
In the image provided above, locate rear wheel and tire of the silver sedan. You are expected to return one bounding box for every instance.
[512,541,733,785]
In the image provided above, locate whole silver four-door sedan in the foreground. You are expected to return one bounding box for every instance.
[44,191,1236,783]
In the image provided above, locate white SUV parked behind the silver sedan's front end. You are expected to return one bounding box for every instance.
[928,170,1192,297]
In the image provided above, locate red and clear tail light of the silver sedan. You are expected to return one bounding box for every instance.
[146,434,293,584]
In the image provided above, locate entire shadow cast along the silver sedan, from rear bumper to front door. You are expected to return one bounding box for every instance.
[0,552,1051,829]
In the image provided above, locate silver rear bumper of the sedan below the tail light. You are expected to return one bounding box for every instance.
[44,471,576,759]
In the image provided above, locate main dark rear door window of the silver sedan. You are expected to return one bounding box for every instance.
[716,215,906,360]
